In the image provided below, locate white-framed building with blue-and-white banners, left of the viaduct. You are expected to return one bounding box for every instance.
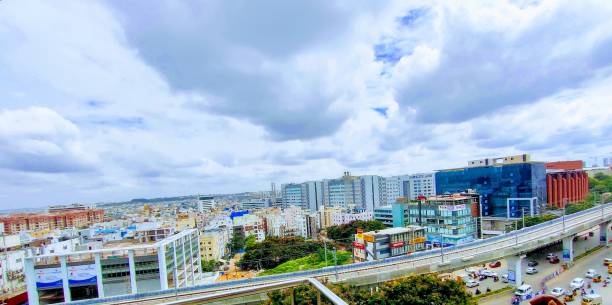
[24,229,202,305]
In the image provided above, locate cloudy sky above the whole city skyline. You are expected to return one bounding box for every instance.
[0,0,612,208]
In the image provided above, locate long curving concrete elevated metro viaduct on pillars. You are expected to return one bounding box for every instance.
[59,203,612,305]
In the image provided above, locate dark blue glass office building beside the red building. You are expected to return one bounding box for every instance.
[436,162,547,217]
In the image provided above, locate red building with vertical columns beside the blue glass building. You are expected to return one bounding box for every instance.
[546,160,589,208]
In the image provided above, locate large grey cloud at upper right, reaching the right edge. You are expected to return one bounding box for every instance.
[395,3,612,123]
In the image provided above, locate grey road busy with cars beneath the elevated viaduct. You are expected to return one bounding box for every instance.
[480,229,612,305]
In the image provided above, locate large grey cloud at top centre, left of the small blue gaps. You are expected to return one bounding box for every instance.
[109,0,370,140]
